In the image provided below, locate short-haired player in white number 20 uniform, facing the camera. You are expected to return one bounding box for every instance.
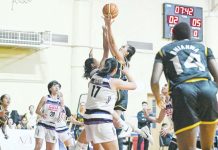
[35,81,63,150]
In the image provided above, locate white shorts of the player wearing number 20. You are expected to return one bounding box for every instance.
[35,125,57,143]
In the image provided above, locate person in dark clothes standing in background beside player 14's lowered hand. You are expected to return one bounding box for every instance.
[137,101,152,150]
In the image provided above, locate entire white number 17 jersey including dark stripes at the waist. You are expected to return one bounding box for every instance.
[84,74,117,125]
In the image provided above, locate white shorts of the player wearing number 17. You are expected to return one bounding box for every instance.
[85,123,117,144]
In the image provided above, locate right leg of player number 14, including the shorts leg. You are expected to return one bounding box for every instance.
[198,81,218,150]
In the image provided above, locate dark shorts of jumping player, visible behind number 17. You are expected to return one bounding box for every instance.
[114,90,128,111]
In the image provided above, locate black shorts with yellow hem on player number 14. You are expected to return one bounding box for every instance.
[171,80,218,134]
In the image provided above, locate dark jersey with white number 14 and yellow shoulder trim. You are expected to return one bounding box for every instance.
[155,39,214,89]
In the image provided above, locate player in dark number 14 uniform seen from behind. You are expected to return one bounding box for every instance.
[151,22,218,150]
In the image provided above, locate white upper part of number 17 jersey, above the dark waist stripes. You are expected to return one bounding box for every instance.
[86,74,117,113]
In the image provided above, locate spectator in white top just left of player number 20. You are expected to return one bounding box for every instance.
[25,105,37,129]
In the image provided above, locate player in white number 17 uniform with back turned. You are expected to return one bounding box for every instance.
[84,58,136,150]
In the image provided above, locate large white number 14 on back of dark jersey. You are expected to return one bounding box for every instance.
[171,53,205,75]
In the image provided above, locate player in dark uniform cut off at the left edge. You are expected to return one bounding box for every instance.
[0,94,11,139]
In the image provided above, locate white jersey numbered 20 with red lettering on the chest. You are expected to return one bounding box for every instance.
[38,95,63,127]
